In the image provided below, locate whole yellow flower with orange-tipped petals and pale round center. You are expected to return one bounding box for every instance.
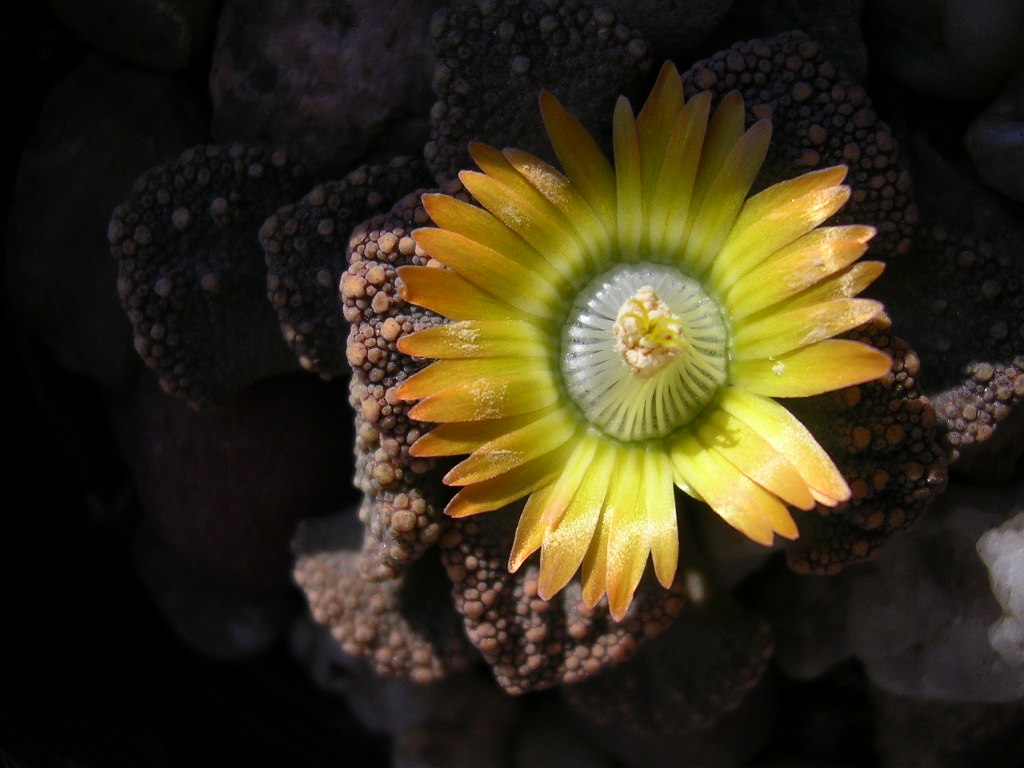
[398,65,891,618]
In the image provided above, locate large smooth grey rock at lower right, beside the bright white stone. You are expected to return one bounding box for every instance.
[848,486,1024,702]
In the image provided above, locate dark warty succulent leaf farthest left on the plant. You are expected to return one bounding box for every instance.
[108,144,308,409]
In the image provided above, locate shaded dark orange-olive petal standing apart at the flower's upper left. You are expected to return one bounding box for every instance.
[540,91,615,221]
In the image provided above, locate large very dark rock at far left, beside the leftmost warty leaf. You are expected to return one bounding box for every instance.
[6,56,207,392]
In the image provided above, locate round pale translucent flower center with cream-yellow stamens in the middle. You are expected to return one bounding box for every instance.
[561,263,728,440]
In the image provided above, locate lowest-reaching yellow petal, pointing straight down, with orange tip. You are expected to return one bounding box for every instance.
[601,447,650,622]
